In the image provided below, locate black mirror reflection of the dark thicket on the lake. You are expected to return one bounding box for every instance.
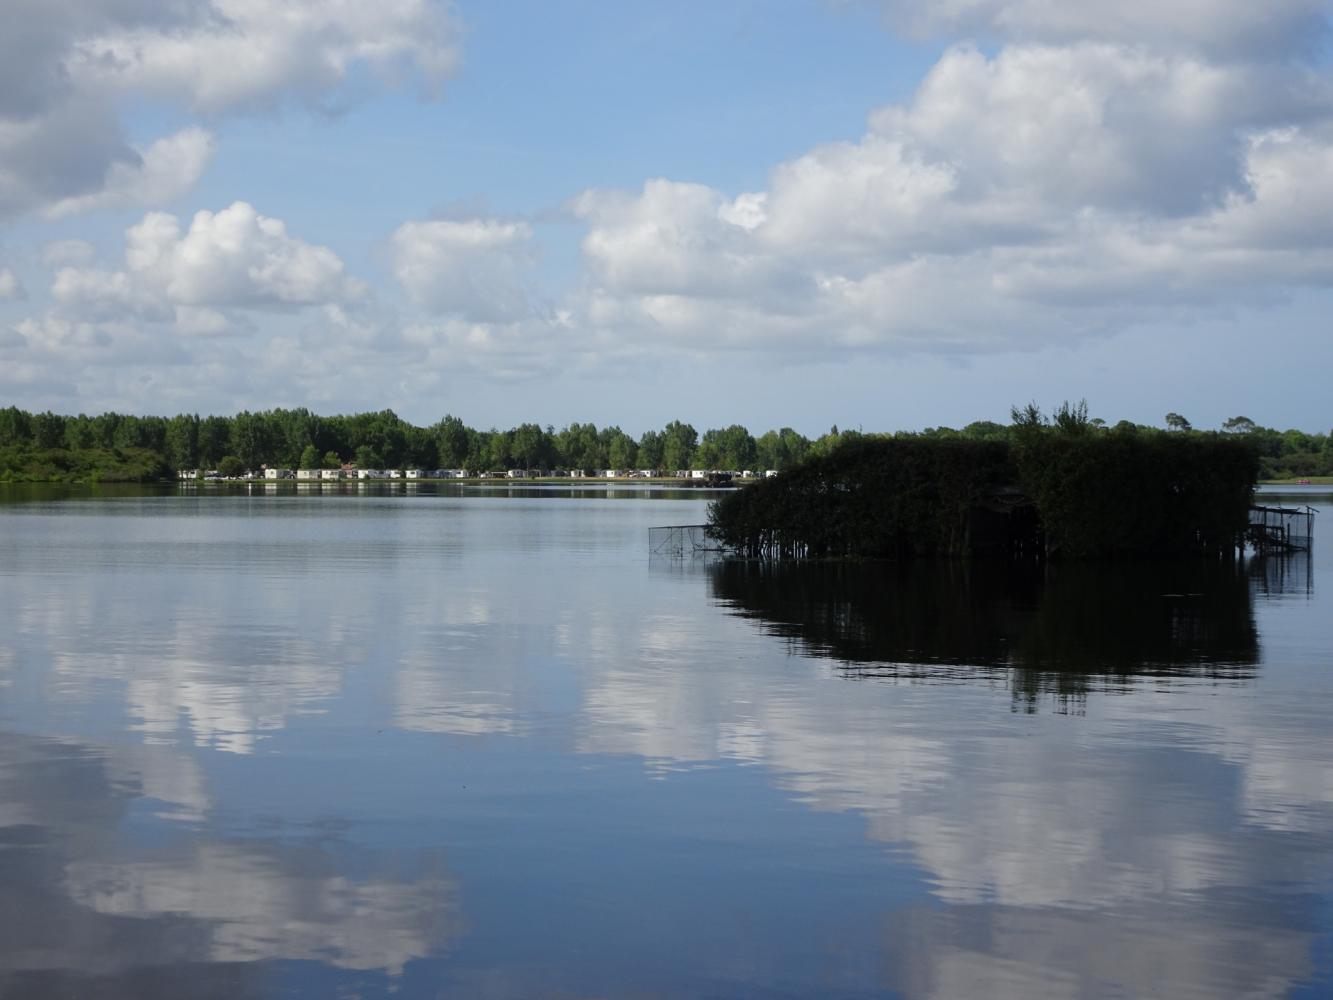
[709,560,1273,712]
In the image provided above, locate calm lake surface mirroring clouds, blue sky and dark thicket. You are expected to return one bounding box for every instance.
[0,488,1333,997]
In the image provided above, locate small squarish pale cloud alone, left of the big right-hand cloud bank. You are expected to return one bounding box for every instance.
[392,219,532,321]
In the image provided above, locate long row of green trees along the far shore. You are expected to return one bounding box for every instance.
[0,407,1333,480]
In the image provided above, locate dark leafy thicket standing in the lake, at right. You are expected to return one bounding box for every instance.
[710,404,1258,559]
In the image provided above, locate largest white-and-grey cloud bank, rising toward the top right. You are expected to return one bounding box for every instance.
[571,8,1333,352]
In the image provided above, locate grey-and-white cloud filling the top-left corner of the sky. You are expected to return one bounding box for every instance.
[0,0,459,217]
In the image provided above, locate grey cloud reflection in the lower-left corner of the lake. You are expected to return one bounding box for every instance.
[0,733,461,996]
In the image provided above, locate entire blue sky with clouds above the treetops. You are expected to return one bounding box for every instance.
[0,0,1333,435]
